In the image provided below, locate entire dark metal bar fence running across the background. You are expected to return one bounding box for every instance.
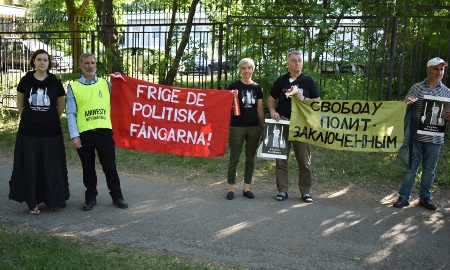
[0,3,450,107]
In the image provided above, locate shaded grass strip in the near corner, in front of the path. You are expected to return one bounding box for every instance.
[0,222,237,270]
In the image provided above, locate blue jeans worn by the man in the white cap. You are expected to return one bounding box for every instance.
[399,140,441,200]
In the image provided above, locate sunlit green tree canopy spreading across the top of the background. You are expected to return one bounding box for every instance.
[19,0,450,98]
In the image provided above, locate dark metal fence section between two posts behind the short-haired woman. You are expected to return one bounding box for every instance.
[225,16,391,99]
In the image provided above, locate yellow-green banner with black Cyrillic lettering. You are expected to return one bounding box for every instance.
[289,99,406,152]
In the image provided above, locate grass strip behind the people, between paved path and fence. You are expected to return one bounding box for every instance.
[0,109,450,189]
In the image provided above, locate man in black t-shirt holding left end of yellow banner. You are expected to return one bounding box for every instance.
[267,51,320,203]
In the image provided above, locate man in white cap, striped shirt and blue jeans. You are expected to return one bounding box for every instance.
[394,57,450,210]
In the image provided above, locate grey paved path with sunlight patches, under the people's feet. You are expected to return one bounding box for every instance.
[0,160,450,269]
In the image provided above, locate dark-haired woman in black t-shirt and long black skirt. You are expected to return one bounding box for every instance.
[9,49,70,215]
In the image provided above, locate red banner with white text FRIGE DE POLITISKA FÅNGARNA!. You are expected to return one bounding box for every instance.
[111,75,233,157]
